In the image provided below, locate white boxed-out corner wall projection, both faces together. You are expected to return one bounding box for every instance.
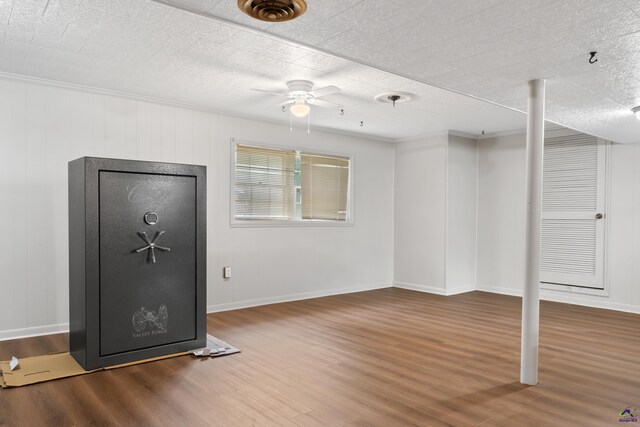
[394,133,477,295]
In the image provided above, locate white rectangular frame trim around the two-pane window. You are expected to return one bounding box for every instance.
[229,138,355,228]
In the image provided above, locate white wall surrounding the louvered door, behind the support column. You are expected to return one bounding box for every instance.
[478,134,640,312]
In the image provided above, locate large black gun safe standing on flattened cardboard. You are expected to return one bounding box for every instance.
[69,157,207,370]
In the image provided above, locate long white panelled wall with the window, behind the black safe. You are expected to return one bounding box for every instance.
[0,79,394,339]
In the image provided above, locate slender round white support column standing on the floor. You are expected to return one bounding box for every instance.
[520,80,545,385]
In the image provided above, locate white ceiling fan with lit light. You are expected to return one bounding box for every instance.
[252,80,342,117]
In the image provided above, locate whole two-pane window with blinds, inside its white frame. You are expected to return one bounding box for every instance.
[232,143,351,224]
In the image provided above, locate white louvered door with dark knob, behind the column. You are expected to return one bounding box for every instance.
[540,131,606,289]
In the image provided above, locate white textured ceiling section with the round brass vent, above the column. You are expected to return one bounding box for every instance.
[161,0,640,142]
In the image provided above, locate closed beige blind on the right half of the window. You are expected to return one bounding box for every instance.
[300,153,349,221]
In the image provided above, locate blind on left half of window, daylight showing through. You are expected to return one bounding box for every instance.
[235,144,296,220]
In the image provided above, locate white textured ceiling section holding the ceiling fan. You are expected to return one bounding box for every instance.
[0,0,526,139]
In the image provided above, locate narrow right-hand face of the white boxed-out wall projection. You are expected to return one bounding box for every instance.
[446,134,478,294]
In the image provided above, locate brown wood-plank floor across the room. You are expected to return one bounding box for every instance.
[0,288,640,426]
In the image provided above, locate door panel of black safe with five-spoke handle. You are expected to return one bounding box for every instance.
[99,171,197,356]
